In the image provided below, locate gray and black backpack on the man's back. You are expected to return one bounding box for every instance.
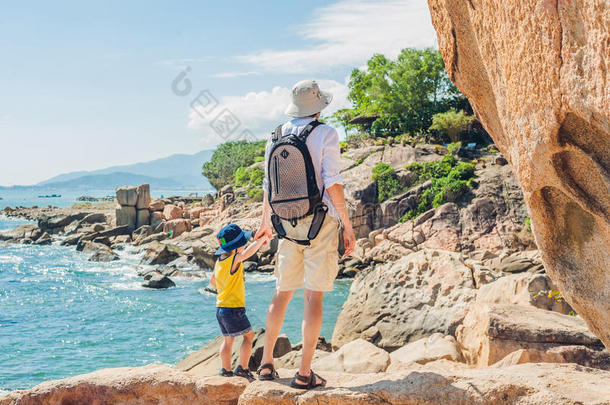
[267,120,328,245]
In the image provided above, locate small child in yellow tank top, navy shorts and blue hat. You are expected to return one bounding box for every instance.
[210,224,268,379]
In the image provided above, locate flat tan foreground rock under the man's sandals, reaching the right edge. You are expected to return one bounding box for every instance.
[239,363,610,405]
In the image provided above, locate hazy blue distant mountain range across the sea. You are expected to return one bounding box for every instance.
[0,150,214,190]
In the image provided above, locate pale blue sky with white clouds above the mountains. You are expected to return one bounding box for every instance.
[0,0,436,185]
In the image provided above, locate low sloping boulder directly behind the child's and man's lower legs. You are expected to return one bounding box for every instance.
[176,329,292,377]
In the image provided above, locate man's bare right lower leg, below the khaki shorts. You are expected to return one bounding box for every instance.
[296,289,324,385]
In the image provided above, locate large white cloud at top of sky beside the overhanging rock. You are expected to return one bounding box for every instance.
[238,0,436,73]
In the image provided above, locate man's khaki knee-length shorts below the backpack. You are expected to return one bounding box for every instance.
[275,215,339,292]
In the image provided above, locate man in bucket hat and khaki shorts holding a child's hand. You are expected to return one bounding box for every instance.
[255,80,356,389]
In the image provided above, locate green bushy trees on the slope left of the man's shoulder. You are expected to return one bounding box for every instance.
[202,141,266,189]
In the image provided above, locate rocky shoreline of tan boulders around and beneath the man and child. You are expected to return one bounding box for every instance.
[0,145,610,405]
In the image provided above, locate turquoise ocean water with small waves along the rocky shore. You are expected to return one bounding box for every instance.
[0,190,350,392]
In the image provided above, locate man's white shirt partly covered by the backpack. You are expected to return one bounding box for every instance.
[263,118,343,219]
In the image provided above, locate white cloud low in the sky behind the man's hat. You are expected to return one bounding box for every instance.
[188,80,350,147]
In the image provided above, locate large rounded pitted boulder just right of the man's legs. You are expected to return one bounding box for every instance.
[332,249,477,351]
